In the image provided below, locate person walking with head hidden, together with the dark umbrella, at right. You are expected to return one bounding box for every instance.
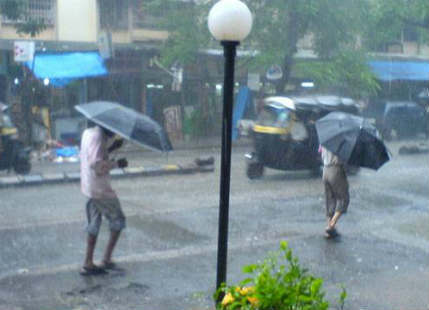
[316,112,390,237]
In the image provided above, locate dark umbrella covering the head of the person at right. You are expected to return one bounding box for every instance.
[316,112,390,170]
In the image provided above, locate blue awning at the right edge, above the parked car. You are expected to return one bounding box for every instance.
[369,60,429,81]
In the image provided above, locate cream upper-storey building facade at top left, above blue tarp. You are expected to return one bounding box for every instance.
[0,0,167,50]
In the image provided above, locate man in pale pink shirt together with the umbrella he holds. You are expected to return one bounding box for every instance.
[75,101,173,275]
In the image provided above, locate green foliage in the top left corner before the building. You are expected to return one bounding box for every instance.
[0,0,46,37]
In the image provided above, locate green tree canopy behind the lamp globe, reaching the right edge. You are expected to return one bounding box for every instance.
[143,0,429,97]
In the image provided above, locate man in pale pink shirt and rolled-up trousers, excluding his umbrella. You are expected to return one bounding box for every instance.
[80,125,128,275]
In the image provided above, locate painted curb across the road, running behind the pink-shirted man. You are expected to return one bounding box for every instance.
[0,164,214,189]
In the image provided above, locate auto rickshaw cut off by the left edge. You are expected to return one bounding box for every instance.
[0,103,31,174]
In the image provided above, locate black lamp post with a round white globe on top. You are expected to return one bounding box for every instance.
[208,0,252,300]
